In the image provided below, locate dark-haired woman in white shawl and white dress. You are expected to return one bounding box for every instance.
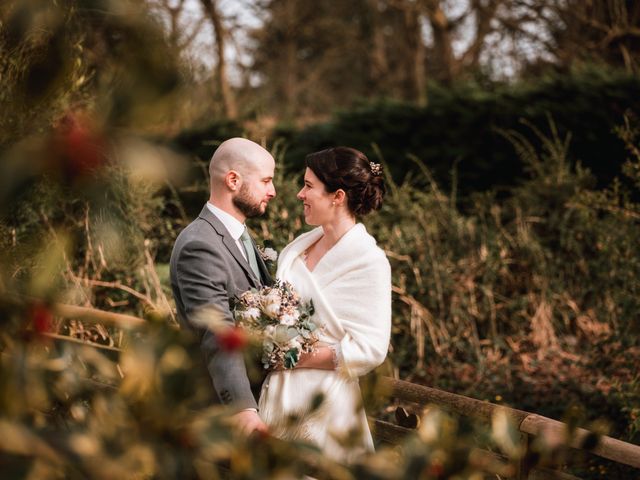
[259,147,391,463]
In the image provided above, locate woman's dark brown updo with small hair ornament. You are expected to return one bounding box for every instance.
[305,147,386,216]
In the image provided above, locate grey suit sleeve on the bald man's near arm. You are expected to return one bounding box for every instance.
[177,241,258,409]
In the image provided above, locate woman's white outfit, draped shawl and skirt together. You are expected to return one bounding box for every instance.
[259,224,391,463]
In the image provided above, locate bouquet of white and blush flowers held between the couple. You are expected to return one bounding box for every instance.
[234,280,318,369]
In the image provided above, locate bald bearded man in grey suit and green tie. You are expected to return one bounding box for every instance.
[170,138,276,433]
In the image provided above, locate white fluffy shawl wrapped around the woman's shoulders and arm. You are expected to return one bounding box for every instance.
[276,223,391,378]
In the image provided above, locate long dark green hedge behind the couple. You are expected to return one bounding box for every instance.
[276,67,640,198]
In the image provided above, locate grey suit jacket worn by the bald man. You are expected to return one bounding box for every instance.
[170,205,271,409]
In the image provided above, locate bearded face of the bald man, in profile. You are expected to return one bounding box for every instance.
[232,158,276,218]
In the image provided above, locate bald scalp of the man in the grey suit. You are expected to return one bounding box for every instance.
[209,137,275,191]
